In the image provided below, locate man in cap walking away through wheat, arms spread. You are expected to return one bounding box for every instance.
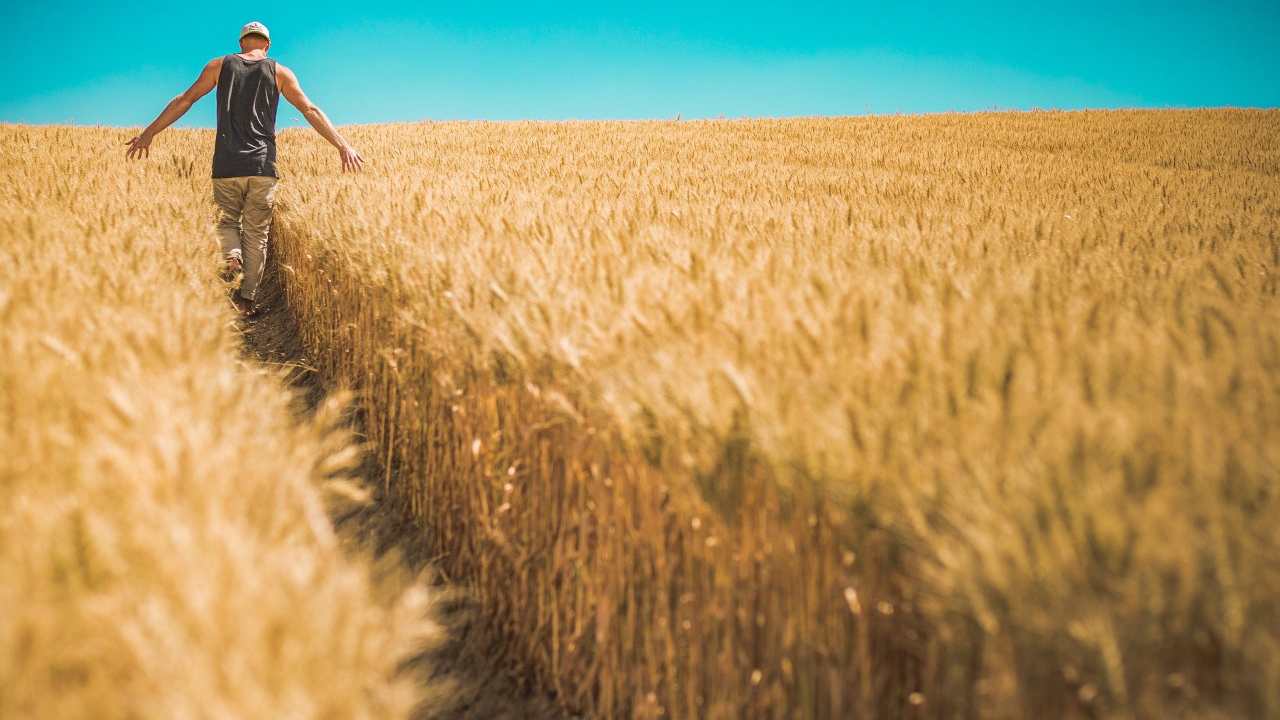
[125,22,364,316]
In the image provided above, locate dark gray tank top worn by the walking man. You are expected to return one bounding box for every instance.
[214,55,280,178]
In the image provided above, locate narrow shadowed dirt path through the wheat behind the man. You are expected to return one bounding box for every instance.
[241,261,567,720]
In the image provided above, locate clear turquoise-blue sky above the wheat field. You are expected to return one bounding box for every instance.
[0,0,1280,127]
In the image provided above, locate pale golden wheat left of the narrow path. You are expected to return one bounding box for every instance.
[0,126,438,719]
